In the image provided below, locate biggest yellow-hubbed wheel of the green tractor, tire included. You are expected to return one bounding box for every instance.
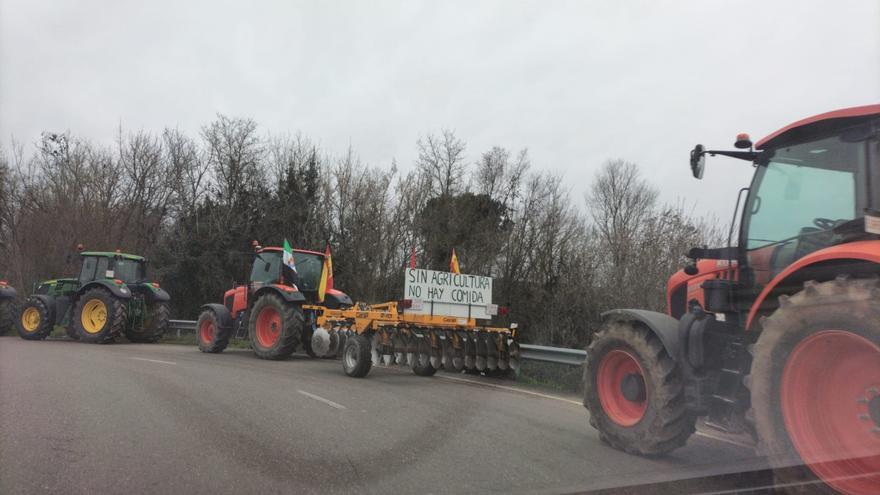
[73,287,127,344]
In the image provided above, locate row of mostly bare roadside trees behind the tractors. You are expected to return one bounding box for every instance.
[0,115,720,354]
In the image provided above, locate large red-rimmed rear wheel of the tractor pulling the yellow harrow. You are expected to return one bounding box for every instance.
[248,293,305,359]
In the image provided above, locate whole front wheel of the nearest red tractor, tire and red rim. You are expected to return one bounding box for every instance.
[584,321,696,455]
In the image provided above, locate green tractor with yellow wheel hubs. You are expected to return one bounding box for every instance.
[18,250,171,344]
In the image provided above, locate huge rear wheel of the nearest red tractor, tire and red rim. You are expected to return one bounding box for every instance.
[748,278,880,495]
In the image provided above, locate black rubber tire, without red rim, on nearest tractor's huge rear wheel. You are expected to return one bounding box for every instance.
[746,277,880,494]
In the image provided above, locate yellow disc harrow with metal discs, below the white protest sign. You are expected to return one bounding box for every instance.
[308,303,519,376]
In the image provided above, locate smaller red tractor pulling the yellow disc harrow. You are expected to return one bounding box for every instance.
[196,244,352,359]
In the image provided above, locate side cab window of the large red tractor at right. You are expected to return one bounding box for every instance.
[744,137,866,276]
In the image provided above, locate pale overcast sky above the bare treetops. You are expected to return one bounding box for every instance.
[0,0,880,223]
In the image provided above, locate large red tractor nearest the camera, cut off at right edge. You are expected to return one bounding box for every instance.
[584,105,880,495]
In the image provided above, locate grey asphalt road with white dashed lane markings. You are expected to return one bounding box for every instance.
[0,337,763,494]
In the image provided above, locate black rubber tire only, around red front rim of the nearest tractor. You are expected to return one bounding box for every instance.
[584,321,696,455]
